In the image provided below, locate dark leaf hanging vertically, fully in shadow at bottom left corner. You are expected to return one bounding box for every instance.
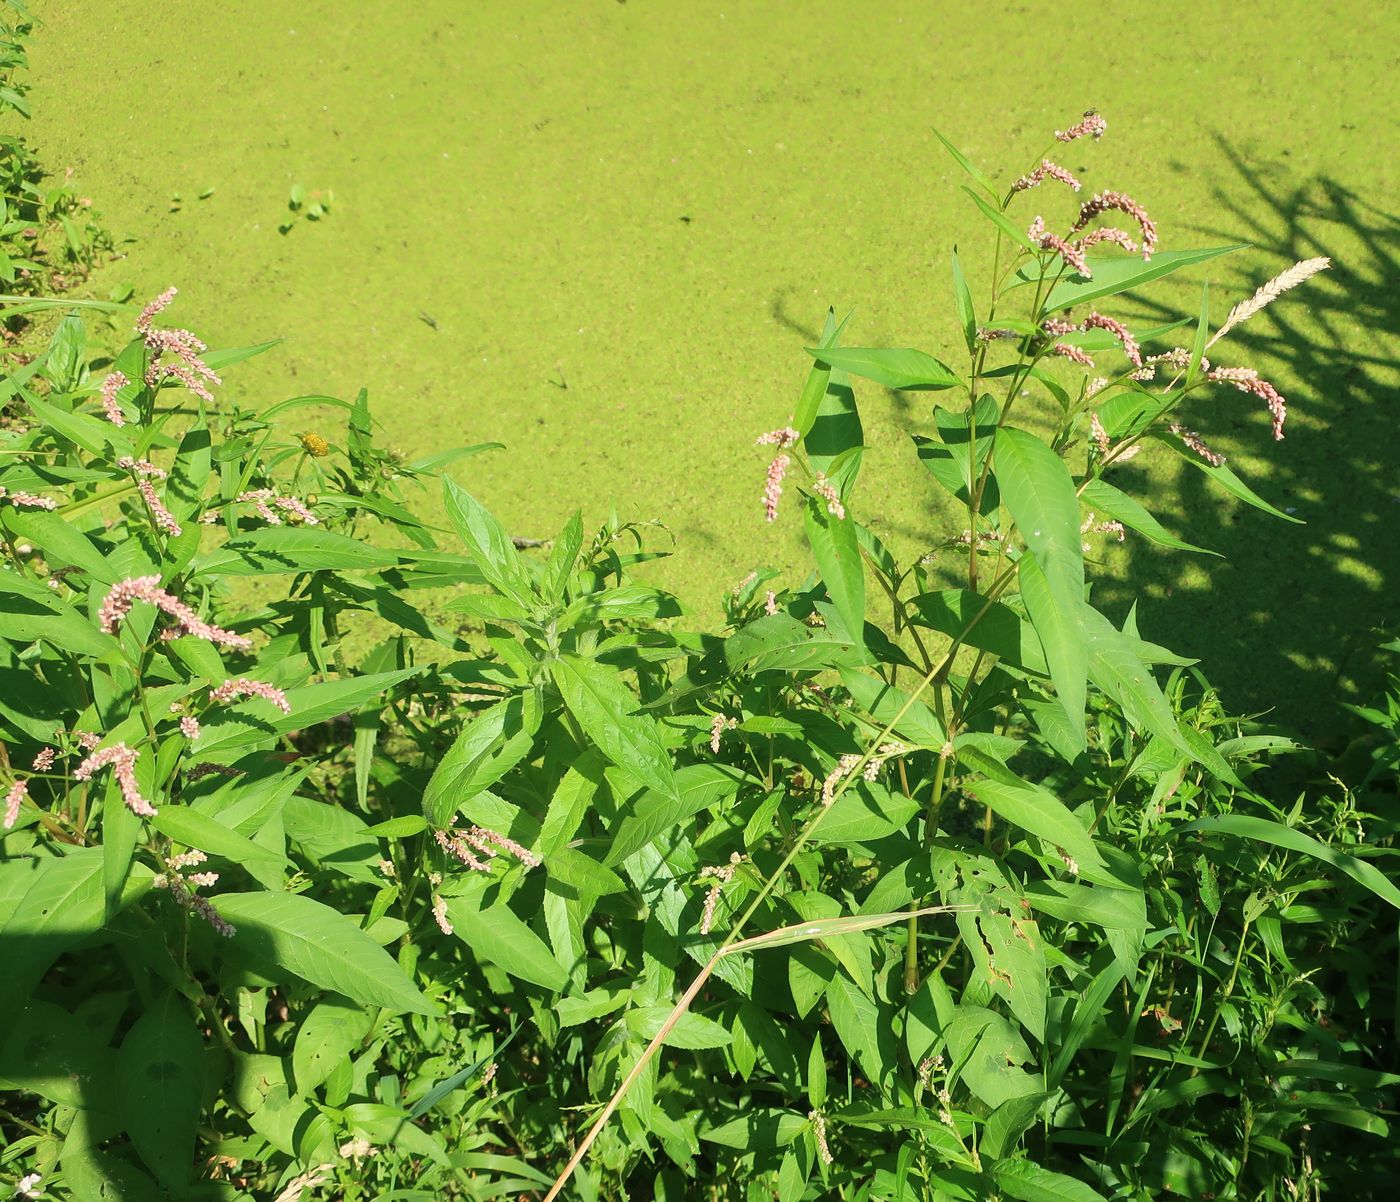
[116,994,204,1194]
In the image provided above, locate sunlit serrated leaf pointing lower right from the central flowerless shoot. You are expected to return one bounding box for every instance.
[553,658,680,802]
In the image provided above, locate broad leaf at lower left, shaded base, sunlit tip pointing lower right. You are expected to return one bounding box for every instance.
[213,893,434,1014]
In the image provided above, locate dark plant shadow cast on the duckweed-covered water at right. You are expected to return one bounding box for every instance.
[1098,139,1400,743]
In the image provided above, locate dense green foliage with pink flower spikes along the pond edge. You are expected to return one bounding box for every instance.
[0,110,1400,1202]
